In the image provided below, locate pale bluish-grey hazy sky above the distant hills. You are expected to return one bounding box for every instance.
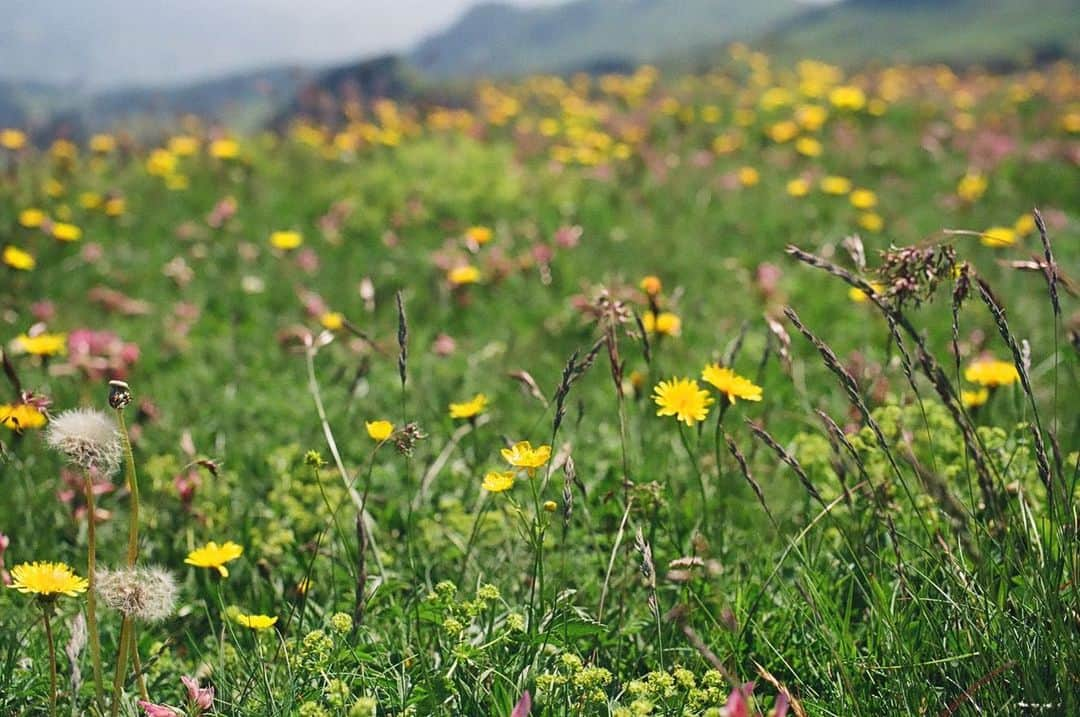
[0,0,561,89]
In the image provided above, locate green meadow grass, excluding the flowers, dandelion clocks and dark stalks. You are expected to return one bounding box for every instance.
[0,56,1080,715]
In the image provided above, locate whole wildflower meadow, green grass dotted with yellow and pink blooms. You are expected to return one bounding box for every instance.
[0,45,1080,717]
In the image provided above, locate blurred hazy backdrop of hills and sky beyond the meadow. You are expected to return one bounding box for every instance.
[0,0,1080,138]
